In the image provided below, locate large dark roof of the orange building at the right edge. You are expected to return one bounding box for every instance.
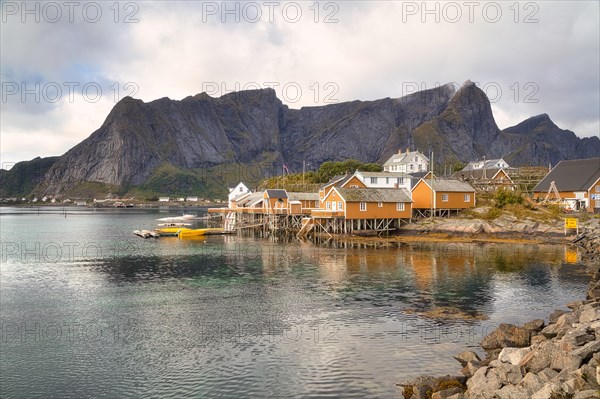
[533,157,600,191]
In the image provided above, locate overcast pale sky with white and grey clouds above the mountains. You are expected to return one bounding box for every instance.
[0,0,600,167]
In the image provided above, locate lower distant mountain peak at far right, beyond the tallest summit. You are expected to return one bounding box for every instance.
[489,114,600,165]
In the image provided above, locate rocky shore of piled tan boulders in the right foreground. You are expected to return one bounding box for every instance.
[399,219,600,399]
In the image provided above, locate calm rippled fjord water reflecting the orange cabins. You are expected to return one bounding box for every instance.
[0,208,588,398]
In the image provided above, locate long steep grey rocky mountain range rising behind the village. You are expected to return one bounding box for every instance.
[5,81,600,195]
